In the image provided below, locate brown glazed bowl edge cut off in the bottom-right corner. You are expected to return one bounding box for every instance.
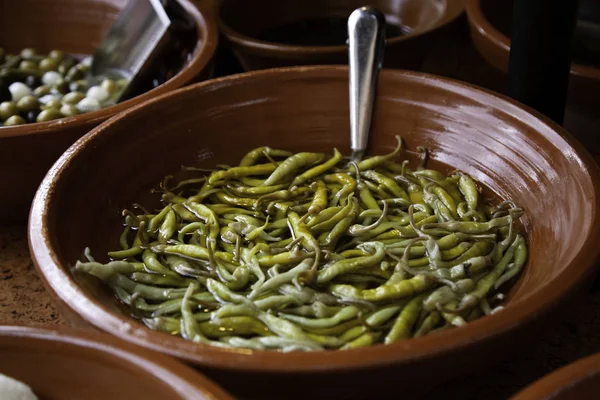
[511,353,600,400]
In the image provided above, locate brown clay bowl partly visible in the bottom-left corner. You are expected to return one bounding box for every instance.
[0,326,232,400]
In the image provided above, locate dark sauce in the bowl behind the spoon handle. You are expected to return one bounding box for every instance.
[257,17,411,46]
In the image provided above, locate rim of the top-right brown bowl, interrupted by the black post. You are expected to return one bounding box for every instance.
[465,0,600,80]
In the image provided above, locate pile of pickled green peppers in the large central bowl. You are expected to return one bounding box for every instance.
[75,137,527,351]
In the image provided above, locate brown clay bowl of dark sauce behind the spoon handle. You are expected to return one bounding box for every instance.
[219,0,466,70]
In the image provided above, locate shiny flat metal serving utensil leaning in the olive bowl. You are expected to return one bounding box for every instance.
[87,0,193,102]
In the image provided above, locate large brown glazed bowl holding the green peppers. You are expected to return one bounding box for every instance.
[29,66,600,399]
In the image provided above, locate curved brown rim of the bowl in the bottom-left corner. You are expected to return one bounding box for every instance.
[0,324,233,400]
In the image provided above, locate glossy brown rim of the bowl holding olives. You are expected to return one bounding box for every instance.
[0,0,219,139]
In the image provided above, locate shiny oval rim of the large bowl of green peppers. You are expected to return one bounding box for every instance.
[28,66,600,373]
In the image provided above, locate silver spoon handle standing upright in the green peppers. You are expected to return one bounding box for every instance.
[348,7,385,161]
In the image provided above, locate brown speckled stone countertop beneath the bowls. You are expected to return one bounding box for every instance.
[0,220,600,400]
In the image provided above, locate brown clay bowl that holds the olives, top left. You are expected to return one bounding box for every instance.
[0,0,218,221]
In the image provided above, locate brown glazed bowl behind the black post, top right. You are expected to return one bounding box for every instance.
[466,0,600,161]
